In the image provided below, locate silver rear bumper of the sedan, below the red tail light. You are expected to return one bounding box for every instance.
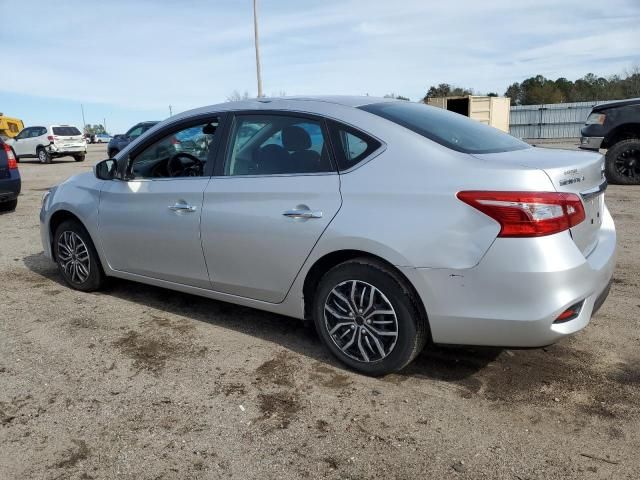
[403,206,616,347]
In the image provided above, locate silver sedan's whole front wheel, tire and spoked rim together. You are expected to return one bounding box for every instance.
[53,220,105,292]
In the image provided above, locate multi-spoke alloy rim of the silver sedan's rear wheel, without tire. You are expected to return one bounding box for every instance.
[324,280,398,363]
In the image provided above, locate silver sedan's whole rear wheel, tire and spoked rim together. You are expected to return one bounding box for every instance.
[313,258,428,375]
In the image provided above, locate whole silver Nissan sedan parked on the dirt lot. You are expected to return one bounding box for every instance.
[40,97,616,375]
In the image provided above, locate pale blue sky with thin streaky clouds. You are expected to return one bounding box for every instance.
[0,0,640,134]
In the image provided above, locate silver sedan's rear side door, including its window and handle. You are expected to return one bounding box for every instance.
[202,113,341,303]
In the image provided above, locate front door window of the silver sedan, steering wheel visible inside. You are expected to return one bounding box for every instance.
[127,119,218,179]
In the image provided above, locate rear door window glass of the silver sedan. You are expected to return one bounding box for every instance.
[225,115,333,176]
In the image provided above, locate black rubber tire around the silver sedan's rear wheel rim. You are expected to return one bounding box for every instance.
[313,257,429,376]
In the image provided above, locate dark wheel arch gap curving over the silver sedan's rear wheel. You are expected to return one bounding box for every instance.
[302,249,431,337]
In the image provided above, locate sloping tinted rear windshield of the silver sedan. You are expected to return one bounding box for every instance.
[359,102,529,153]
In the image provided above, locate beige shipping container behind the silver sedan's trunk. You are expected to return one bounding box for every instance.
[427,95,511,132]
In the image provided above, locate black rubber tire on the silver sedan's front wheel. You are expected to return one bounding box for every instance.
[53,220,106,292]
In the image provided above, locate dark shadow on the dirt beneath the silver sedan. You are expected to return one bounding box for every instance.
[23,253,502,383]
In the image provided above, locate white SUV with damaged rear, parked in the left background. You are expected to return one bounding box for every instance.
[6,125,87,163]
